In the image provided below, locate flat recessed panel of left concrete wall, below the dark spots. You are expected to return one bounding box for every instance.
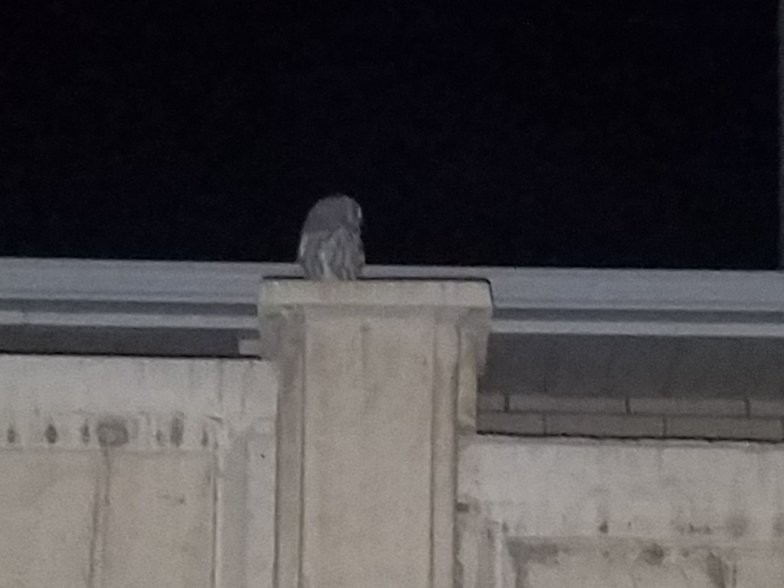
[0,449,214,588]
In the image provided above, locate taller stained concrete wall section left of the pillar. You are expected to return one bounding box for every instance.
[0,356,277,588]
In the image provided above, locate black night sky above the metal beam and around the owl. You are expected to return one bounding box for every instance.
[0,0,778,268]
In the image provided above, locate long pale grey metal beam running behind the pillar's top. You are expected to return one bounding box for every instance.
[0,259,784,338]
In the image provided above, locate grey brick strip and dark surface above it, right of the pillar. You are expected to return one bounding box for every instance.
[479,336,784,442]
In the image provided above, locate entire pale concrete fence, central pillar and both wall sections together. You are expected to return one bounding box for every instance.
[0,281,784,588]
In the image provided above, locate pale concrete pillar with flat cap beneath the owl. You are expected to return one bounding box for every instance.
[260,280,491,588]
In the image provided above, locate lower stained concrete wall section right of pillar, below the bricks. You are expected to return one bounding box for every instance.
[458,437,784,588]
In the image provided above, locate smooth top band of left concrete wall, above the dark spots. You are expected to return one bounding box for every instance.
[0,355,277,422]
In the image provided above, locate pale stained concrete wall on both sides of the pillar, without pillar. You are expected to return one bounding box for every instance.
[0,356,784,588]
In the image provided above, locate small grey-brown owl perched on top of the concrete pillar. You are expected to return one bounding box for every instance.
[297,194,365,280]
